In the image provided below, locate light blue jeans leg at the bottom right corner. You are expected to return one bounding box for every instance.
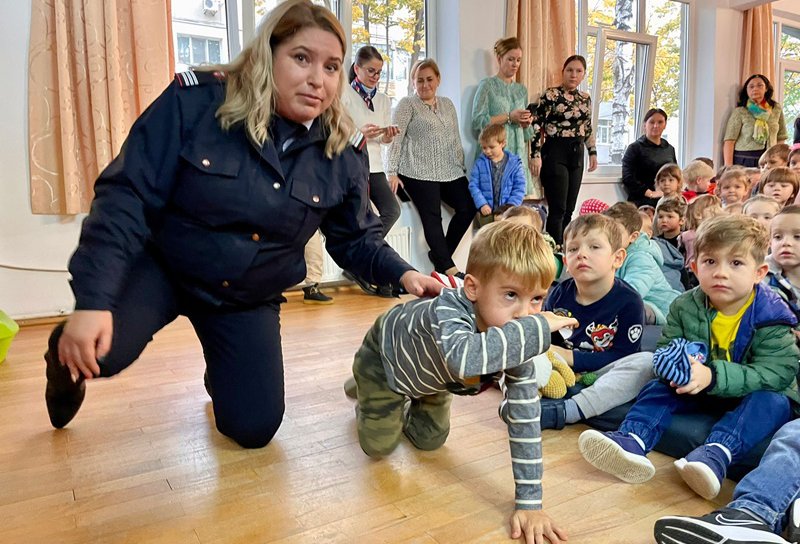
[728,419,800,533]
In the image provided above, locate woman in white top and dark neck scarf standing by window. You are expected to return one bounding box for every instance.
[342,45,400,297]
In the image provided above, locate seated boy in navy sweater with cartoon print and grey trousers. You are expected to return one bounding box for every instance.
[541,214,653,429]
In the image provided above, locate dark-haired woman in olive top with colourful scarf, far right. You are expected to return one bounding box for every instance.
[722,74,788,167]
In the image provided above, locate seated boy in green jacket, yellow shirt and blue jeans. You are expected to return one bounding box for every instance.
[578,215,800,499]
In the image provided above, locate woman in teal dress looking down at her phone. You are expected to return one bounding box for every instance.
[472,37,542,198]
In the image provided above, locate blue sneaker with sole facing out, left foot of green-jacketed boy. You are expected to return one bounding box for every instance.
[578,430,656,484]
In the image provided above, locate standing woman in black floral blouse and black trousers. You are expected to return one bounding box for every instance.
[531,55,597,244]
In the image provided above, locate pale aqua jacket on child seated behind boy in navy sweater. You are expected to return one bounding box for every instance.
[616,233,680,325]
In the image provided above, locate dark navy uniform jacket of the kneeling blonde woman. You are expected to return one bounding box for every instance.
[69,72,412,310]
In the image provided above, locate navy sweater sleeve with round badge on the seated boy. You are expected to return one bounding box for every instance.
[572,292,644,372]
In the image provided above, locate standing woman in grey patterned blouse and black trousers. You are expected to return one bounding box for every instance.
[386,59,475,274]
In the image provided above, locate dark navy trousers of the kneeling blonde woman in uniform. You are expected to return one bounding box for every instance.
[50,254,284,448]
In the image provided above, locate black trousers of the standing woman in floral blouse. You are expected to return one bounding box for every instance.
[540,137,584,244]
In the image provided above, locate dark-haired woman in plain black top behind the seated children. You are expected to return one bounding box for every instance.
[622,108,678,207]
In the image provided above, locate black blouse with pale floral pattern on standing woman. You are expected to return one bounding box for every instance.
[531,86,597,157]
